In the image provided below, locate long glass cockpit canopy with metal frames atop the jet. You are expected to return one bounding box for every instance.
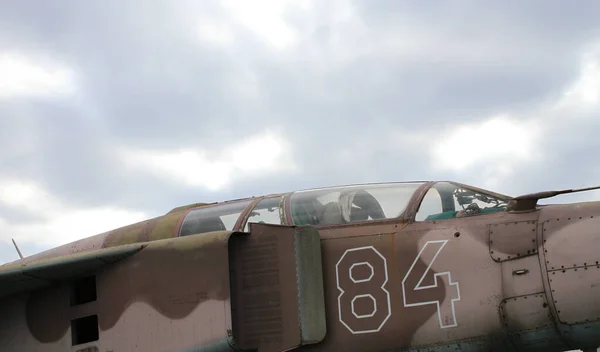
[179,182,510,236]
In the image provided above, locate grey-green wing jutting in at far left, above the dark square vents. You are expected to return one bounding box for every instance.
[0,244,146,298]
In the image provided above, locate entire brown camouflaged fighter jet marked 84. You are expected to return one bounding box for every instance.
[0,181,600,352]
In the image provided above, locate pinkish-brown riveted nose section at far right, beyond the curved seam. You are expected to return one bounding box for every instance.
[540,202,600,333]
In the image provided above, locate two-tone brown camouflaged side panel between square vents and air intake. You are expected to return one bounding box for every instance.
[98,232,232,351]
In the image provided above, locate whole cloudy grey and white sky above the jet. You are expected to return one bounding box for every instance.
[0,0,600,263]
